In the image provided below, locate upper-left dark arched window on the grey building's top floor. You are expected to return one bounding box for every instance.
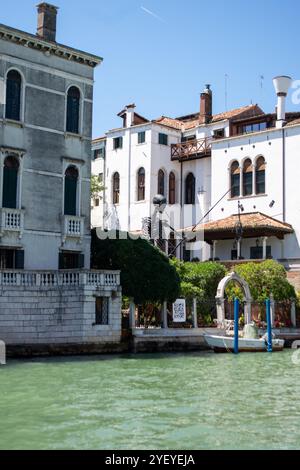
[5,70,22,121]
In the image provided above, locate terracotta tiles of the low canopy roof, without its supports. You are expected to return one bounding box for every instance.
[185,212,294,233]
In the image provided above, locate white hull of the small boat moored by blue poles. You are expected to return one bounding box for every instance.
[204,335,285,353]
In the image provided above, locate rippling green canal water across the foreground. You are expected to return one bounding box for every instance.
[0,351,300,450]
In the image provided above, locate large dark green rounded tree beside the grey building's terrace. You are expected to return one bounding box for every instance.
[91,230,180,305]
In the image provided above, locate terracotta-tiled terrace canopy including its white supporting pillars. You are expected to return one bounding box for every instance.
[185,212,294,259]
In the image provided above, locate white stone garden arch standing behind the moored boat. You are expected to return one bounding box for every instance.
[216,272,252,328]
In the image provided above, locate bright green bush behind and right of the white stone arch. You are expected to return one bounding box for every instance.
[226,260,297,302]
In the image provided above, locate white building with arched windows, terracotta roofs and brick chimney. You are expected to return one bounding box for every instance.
[92,81,300,270]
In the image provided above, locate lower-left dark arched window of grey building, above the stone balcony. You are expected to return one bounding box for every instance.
[2,157,20,209]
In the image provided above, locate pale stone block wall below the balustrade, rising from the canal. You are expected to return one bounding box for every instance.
[0,285,121,347]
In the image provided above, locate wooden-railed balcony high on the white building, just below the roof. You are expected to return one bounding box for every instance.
[171,138,212,161]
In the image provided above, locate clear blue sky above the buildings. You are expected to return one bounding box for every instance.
[0,0,300,137]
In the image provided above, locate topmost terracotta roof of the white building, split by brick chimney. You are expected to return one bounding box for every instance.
[153,104,264,131]
